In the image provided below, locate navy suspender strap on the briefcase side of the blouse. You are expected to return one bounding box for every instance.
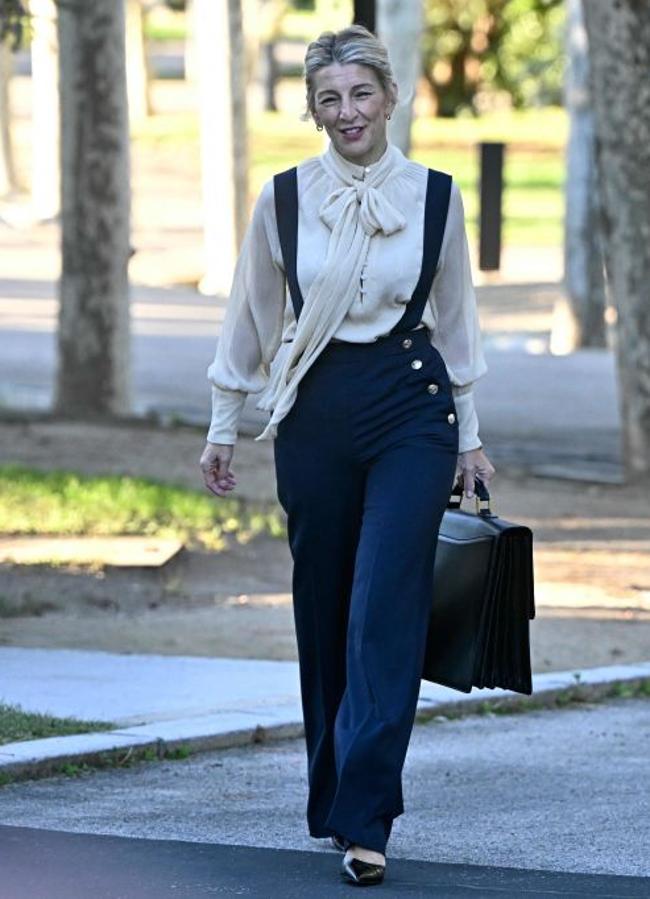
[391,169,451,334]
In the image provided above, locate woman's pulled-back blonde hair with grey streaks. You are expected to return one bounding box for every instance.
[303,25,395,119]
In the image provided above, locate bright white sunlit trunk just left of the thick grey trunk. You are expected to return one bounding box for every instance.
[30,0,61,220]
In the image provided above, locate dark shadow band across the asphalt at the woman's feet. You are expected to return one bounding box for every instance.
[0,826,649,899]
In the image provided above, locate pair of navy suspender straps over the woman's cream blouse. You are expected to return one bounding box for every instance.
[273,166,451,334]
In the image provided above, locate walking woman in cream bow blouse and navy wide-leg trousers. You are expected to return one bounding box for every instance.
[201,26,494,884]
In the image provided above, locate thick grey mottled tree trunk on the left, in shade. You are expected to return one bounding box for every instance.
[55,0,130,416]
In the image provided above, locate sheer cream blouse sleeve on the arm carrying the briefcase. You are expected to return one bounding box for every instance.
[429,182,487,453]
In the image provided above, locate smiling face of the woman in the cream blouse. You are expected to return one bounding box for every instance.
[313,63,396,165]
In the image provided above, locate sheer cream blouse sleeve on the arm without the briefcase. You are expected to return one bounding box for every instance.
[207,181,286,444]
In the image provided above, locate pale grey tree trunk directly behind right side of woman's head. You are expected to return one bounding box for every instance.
[377,0,422,155]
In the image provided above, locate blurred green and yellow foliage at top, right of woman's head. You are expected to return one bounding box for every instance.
[423,0,564,116]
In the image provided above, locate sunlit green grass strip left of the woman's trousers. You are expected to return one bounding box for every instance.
[0,465,284,549]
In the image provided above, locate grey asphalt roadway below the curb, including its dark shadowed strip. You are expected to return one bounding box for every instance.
[0,699,650,899]
